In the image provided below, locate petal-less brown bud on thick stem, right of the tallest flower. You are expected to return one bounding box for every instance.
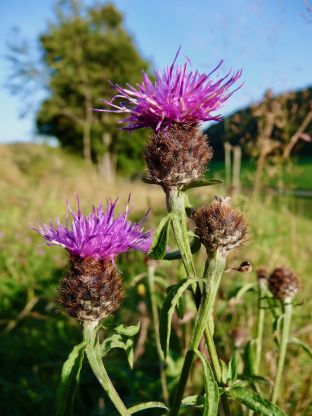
[193,195,249,255]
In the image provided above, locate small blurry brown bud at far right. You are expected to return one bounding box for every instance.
[269,266,299,301]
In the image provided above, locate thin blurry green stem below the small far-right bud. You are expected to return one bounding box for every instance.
[271,298,292,404]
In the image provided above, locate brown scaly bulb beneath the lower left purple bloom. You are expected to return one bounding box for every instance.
[57,256,125,321]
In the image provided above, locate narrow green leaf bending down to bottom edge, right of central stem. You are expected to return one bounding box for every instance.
[195,351,219,416]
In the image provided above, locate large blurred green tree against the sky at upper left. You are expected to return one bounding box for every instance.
[10,0,149,180]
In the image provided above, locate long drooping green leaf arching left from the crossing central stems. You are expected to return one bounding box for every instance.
[159,277,201,362]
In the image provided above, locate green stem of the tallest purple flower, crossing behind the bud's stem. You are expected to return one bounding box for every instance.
[166,188,230,416]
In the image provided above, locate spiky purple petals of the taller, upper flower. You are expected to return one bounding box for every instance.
[93,47,242,133]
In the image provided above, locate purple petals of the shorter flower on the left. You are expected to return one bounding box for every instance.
[30,194,153,267]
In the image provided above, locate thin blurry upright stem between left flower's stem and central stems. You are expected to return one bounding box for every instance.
[147,266,169,404]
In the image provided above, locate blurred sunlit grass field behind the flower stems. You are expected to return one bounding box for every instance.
[0,145,312,416]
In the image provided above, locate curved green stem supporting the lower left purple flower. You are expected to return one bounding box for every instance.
[82,321,130,416]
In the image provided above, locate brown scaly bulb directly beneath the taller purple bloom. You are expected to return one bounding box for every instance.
[142,123,212,186]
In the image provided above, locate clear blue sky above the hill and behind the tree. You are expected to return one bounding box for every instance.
[0,0,312,143]
